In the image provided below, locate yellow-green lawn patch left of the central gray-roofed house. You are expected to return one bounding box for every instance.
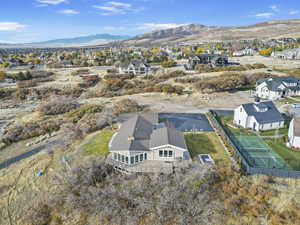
[83,128,115,155]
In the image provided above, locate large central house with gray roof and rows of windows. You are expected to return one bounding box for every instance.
[109,113,190,172]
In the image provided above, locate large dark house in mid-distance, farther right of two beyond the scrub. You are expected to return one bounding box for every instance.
[185,54,228,70]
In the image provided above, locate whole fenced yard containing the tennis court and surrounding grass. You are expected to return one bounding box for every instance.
[211,111,300,178]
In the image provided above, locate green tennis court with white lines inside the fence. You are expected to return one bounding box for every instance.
[232,136,289,169]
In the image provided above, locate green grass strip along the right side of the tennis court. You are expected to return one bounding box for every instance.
[265,138,300,170]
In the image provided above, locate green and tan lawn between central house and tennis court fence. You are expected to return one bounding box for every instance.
[184,132,230,163]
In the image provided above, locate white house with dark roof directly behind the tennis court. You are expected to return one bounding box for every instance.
[233,100,284,131]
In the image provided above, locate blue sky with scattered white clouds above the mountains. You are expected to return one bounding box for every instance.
[0,0,300,43]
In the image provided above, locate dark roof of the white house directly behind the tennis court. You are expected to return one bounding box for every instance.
[242,101,284,124]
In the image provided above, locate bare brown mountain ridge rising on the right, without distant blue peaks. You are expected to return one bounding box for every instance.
[122,19,300,46]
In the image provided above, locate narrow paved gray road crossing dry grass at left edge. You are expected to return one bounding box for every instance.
[0,139,62,170]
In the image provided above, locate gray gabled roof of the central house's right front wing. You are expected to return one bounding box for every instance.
[150,127,187,149]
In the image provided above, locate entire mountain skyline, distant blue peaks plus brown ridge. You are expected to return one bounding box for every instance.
[0,19,300,48]
